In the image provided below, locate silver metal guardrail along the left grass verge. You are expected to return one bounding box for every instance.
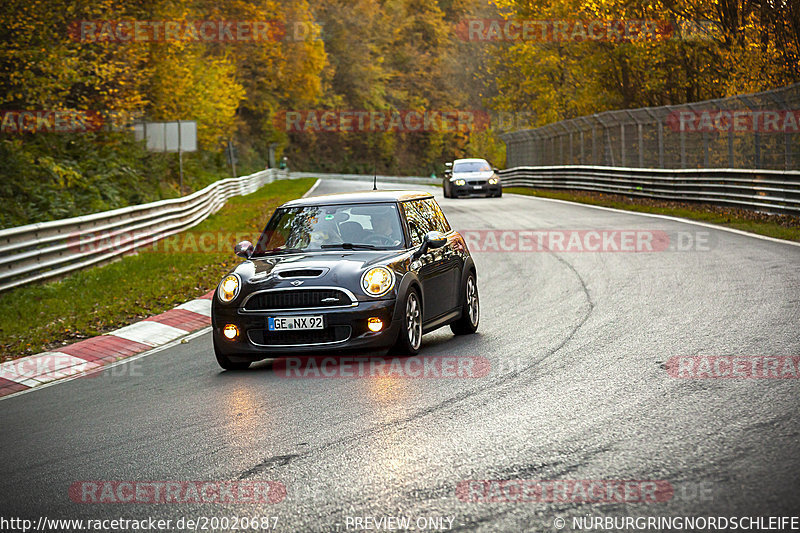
[0,169,289,291]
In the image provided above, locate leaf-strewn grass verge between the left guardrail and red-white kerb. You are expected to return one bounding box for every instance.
[0,179,315,360]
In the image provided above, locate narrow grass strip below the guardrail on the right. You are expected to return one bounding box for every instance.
[503,187,800,241]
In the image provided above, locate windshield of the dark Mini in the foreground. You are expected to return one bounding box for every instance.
[256,203,403,255]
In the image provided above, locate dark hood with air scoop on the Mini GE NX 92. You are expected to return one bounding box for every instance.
[234,250,411,290]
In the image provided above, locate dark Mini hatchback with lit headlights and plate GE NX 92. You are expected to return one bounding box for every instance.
[211,191,480,369]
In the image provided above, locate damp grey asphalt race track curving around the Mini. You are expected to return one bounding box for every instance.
[0,181,800,531]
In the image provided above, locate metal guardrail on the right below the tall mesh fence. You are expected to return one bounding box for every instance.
[499,165,800,216]
